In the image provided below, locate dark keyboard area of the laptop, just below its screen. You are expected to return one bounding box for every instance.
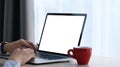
[37,52,67,60]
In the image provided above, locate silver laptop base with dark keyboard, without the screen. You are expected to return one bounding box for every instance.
[27,52,70,65]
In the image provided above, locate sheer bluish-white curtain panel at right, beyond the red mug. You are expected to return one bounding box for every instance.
[92,0,120,57]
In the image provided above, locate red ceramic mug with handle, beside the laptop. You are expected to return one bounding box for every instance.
[68,47,92,65]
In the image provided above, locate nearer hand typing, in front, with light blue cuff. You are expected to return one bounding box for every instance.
[9,48,35,65]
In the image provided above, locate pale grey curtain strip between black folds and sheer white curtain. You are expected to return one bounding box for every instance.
[20,0,34,43]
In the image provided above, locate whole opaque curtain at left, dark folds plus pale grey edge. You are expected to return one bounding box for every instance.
[0,0,34,42]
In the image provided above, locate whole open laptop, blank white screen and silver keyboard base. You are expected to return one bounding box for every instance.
[0,13,87,64]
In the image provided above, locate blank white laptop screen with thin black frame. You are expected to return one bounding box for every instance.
[39,13,86,54]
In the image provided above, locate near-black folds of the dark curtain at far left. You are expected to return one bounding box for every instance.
[3,0,20,42]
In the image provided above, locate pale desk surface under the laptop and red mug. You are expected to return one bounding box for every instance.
[0,56,120,67]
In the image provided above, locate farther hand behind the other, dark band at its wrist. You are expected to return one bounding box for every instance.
[3,39,36,53]
